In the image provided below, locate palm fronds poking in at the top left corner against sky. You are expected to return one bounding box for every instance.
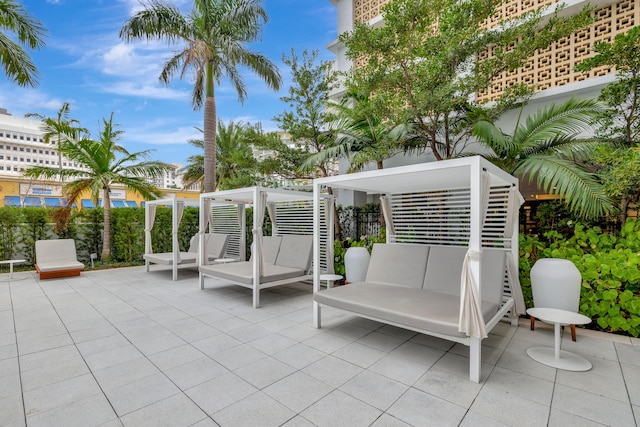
[0,0,46,87]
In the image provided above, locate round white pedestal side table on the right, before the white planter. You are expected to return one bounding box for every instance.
[527,308,592,371]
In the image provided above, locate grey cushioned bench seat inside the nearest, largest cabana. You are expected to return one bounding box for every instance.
[314,244,513,382]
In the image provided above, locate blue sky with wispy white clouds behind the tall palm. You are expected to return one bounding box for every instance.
[0,0,337,164]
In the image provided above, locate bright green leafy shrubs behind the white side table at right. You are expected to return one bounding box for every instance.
[520,220,640,337]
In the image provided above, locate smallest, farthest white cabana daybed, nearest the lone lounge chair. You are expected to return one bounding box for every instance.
[143,198,228,280]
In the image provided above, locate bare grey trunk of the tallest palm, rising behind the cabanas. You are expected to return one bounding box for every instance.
[204,62,216,193]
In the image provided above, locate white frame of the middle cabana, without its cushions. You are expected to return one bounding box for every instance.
[199,186,333,308]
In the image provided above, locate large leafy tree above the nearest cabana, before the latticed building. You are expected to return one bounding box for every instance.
[340,0,591,160]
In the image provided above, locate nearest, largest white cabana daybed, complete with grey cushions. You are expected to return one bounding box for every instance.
[313,156,524,382]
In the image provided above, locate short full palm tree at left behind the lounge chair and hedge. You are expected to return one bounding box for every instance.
[25,113,171,260]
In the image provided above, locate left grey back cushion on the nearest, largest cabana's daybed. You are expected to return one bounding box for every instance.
[366,243,430,289]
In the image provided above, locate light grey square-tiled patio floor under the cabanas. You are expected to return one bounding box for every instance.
[0,267,640,427]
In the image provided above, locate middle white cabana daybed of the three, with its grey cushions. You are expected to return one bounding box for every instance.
[199,187,333,308]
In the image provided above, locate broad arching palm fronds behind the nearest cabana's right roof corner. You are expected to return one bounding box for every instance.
[473,98,615,218]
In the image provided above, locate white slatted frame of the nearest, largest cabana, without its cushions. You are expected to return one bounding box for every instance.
[313,156,524,382]
